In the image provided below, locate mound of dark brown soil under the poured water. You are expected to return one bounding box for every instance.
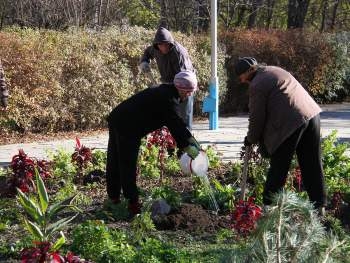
[153,203,229,233]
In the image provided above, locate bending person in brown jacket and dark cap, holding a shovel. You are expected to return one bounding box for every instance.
[235,57,326,214]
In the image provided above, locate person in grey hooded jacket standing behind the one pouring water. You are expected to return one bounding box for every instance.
[140,27,194,130]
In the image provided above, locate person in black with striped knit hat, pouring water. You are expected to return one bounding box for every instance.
[106,71,200,215]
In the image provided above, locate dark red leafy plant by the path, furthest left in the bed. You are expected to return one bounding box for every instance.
[8,149,51,194]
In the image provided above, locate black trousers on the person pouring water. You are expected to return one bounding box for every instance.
[106,126,141,202]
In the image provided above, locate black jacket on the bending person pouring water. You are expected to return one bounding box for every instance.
[108,84,192,151]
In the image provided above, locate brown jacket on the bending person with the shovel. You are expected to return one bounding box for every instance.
[247,66,321,154]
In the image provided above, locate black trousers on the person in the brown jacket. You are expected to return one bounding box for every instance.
[263,115,326,208]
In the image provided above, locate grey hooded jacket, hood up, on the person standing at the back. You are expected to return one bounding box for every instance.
[141,27,194,83]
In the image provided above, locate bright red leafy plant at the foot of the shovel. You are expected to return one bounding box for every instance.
[231,197,262,236]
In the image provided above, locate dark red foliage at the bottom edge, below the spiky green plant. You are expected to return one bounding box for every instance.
[20,241,87,263]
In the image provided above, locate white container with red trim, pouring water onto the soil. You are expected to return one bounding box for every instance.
[180,150,209,177]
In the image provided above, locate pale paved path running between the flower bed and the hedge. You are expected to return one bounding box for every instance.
[0,103,350,166]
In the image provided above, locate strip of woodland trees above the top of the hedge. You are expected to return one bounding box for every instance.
[0,0,350,32]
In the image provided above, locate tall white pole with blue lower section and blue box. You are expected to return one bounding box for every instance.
[203,0,219,130]
